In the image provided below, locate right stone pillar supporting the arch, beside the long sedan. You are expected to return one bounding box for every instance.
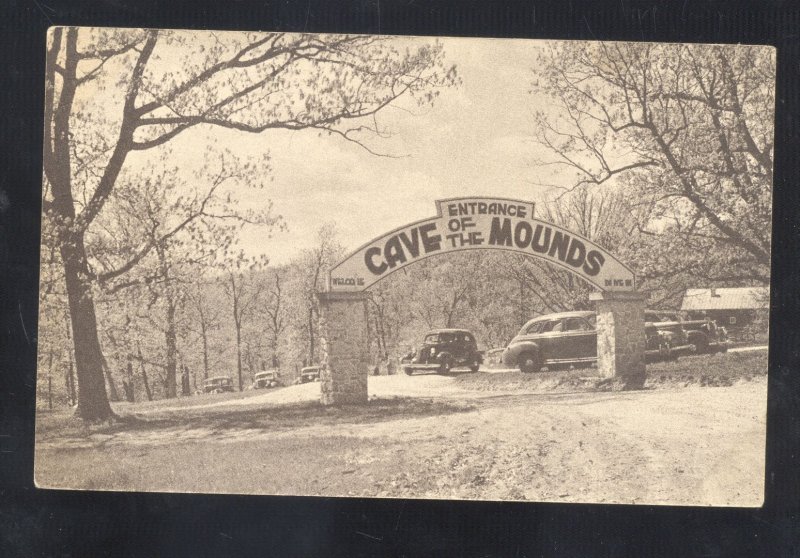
[589,292,647,389]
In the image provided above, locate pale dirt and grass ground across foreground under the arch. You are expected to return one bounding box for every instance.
[36,368,766,506]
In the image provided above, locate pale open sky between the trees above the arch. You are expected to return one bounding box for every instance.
[130,34,554,264]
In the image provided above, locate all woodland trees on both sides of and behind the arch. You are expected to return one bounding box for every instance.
[38,28,774,420]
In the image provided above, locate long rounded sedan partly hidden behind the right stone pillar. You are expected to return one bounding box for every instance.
[503,311,672,373]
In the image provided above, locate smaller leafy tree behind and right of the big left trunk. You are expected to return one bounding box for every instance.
[94,154,281,397]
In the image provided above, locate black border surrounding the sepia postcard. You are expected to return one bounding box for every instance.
[0,0,800,557]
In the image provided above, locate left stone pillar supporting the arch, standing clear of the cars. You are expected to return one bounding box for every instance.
[317,292,369,405]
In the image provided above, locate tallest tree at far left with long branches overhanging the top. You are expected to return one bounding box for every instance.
[43,27,457,421]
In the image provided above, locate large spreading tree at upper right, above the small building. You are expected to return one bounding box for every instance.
[533,42,775,284]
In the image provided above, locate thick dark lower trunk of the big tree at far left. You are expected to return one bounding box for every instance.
[61,242,114,422]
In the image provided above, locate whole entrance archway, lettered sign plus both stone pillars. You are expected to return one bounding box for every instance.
[318,197,645,404]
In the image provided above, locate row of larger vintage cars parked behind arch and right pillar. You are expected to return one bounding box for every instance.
[401,311,727,374]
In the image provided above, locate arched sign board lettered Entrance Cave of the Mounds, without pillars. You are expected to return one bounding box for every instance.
[328,197,636,292]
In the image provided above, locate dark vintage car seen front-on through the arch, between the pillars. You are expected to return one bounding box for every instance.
[401,329,483,375]
